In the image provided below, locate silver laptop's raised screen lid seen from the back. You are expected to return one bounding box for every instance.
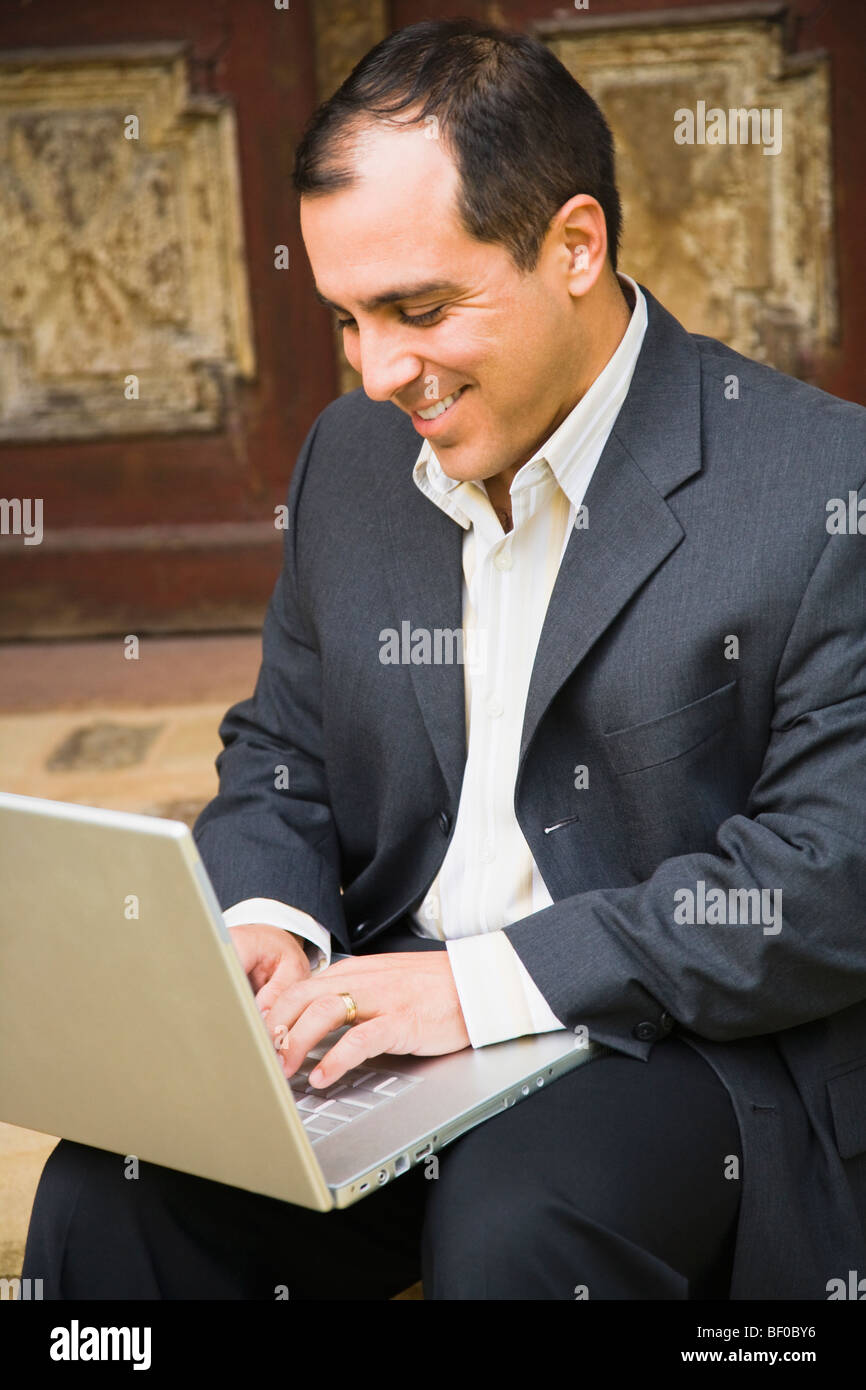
[0,792,334,1211]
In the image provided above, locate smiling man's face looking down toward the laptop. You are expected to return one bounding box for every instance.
[300,126,587,480]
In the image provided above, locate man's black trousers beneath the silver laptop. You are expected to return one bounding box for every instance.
[22,933,741,1300]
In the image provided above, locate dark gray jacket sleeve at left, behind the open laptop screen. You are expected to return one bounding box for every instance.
[193,405,346,938]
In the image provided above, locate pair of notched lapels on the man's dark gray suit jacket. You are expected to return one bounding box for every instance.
[381,285,701,806]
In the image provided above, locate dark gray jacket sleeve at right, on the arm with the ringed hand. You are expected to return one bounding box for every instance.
[505,488,866,1058]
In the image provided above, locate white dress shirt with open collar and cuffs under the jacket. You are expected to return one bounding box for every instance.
[224,272,646,1047]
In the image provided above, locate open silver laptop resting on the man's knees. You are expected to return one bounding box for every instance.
[0,792,609,1211]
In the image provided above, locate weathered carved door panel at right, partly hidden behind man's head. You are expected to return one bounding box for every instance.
[537,4,837,377]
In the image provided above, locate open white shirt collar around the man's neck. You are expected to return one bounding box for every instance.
[413,271,646,528]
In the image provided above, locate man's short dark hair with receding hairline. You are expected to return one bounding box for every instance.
[292,18,621,271]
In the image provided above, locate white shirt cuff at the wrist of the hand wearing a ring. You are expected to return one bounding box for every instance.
[446,931,566,1047]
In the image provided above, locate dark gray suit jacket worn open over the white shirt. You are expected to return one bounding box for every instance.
[195,286,866,1298]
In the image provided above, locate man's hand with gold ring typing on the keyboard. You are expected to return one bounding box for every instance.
[267,951,470,1087]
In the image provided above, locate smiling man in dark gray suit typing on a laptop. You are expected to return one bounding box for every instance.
[25,21,866,1300]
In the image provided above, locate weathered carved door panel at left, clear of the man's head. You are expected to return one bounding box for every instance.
[0,43,254,439]
